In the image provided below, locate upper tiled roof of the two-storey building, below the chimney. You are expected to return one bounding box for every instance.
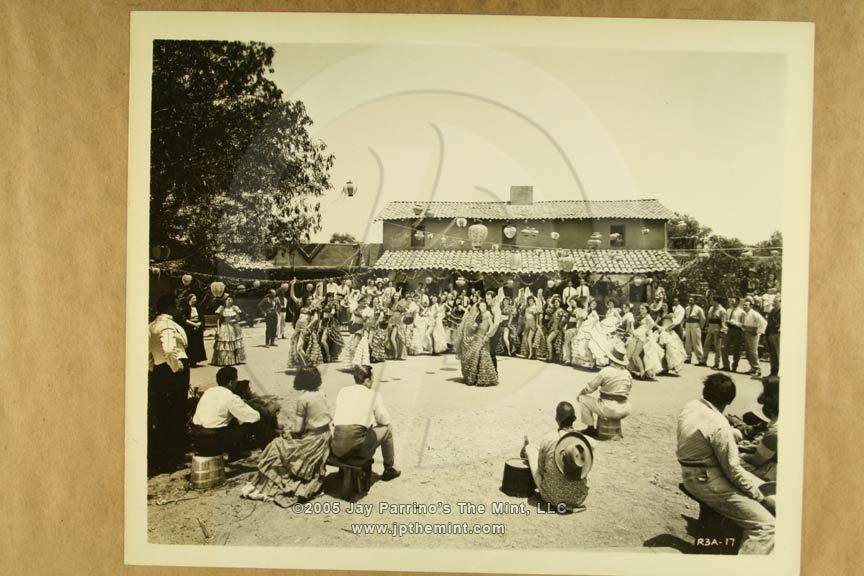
[376,199,675,220]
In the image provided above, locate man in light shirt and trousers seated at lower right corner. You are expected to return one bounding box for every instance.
[677,372,774,554]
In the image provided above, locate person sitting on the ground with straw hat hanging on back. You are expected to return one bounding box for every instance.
[522,402,594,511]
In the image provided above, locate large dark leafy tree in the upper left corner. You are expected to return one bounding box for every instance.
[150,40,333,258]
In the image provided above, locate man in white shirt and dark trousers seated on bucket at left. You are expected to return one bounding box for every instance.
[192,366,272,460]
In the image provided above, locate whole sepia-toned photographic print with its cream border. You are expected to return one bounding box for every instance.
[126,12,813,575]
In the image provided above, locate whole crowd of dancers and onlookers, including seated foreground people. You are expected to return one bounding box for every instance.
[148,278,781,553]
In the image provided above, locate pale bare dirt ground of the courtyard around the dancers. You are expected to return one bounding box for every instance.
[148,325,765,552]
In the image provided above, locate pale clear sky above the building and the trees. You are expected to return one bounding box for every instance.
[272,44,785,243]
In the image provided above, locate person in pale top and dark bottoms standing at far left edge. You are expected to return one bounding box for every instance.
[147,294,189,474]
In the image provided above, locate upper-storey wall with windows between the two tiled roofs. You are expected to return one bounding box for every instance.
[383,220,666,250]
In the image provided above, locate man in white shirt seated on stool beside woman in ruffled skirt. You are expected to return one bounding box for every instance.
[330,366,402,481]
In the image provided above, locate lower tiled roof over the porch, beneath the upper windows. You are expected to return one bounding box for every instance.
[375,249,678,274]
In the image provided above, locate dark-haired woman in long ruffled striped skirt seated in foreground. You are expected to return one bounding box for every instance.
[240,366,333,506]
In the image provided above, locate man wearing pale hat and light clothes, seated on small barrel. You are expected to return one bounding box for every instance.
[579,341,633,436]
